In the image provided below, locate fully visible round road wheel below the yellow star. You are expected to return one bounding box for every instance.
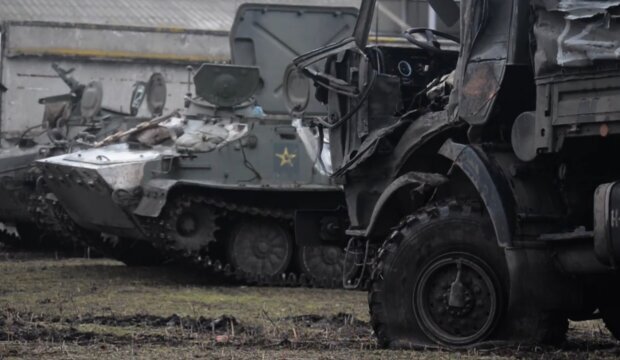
[227,219,294,278]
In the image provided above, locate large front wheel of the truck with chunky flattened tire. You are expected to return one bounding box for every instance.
[369,203,509,347]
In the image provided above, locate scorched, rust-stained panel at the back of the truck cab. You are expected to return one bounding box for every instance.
[450,0,529,125]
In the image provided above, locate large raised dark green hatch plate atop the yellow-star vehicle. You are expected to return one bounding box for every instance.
[230,4,358,115]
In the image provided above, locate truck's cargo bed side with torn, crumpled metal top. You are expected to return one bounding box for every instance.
[513,0,620,161]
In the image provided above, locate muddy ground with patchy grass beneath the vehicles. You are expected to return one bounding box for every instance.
[0,250,620,360]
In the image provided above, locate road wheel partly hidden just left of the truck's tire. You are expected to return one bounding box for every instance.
[297,245,345,287]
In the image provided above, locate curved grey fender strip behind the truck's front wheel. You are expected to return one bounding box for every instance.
[439,140,514,248]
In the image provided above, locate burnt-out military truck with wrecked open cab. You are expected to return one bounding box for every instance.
[291,0,620,347]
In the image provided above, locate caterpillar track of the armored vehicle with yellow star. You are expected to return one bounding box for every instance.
[42,191,342,288]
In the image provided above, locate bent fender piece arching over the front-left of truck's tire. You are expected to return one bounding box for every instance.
[347,172,448,237]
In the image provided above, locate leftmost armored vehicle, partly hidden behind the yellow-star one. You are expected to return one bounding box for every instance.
[0,64,165,248]
